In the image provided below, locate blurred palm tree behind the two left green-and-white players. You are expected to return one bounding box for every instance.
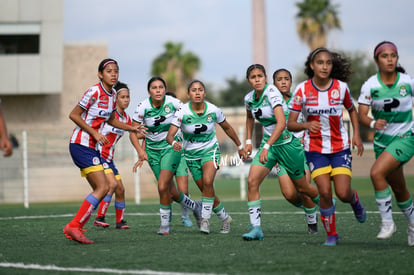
[151,41,201,102]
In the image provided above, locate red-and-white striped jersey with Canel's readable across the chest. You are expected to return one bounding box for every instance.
[289,79,354,154]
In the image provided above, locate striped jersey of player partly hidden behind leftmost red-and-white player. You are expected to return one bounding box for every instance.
[97,111,132,162]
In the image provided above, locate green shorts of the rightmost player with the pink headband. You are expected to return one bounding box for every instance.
[374,133,414,165]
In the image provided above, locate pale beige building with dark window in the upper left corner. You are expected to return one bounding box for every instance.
[0,0,63,127]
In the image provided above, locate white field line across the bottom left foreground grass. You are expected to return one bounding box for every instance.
[0,262,223,275]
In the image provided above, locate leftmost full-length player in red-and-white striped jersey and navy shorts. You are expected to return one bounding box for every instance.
[63,58,142,244]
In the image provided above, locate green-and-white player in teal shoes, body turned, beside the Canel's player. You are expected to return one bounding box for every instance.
[242,64,319,240]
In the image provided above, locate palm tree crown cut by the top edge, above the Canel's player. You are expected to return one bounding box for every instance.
[296,0,341,50]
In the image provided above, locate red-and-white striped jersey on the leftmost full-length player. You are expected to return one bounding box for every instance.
[70,83,116,149]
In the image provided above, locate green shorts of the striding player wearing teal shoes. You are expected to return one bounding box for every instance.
[252,138,306,179]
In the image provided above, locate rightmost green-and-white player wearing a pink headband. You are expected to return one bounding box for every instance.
[358,41,414,246]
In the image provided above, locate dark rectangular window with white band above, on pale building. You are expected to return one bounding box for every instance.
[0,23,40,55]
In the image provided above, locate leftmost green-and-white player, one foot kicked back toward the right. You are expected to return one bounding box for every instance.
[130,77,201,235]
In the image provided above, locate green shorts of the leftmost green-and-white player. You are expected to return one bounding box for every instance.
[145,147,182,180]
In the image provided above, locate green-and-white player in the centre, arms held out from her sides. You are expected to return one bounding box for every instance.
[167,80,246,234]
